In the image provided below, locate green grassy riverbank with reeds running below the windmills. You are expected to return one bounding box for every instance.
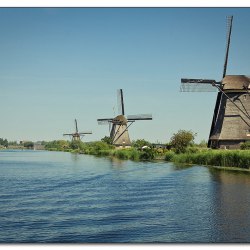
[45,141,250,169]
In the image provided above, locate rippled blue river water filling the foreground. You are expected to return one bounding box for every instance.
[0,151,250,243]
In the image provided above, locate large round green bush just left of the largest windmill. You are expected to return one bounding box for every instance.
[170,130,196,154]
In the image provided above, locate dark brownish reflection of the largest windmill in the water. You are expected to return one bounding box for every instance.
[210,169,250,242]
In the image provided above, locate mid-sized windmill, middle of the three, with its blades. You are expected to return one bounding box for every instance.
[97,89,152,147]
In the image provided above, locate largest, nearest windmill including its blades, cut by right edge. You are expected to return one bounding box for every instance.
[181,16,250,149]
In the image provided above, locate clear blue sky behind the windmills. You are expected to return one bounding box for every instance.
[0,8,250,143]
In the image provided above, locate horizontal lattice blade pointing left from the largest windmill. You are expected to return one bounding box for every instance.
[180,78,220,92]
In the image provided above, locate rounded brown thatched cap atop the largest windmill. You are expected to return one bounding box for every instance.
[222,75,250,90]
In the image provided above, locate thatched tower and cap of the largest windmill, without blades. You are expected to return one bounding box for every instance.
[209,75,250,149]
